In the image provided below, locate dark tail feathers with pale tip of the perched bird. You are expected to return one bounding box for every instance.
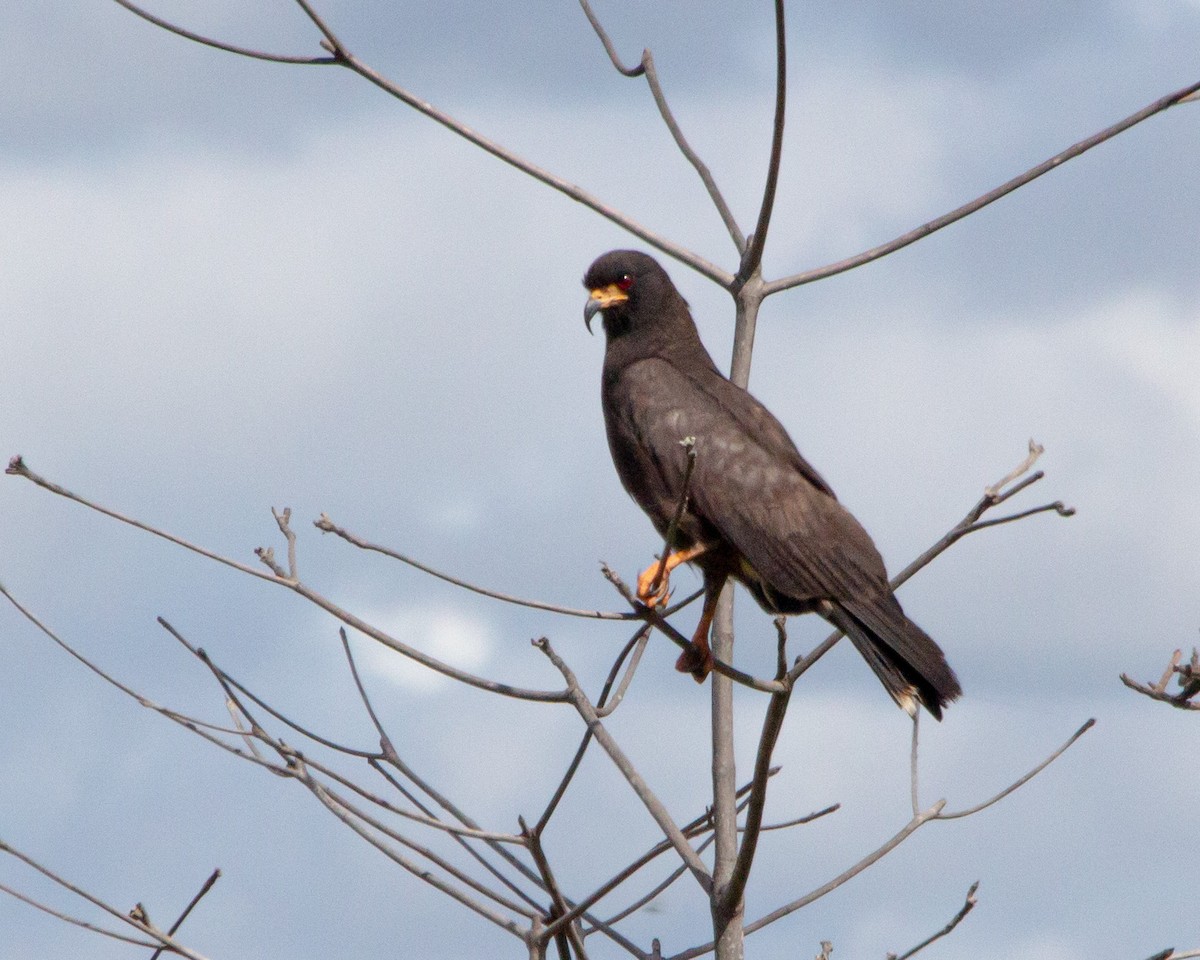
[822,594,962,720]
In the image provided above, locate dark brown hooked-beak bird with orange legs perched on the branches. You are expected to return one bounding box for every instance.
[583,250,962,720]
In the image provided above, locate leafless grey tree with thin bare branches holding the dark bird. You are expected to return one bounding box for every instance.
[0,0,1200,960]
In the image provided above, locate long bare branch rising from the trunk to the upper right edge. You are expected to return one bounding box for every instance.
[766,82,1200,295]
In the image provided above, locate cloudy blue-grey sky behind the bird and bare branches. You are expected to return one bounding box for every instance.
[0,0,1200,960]
